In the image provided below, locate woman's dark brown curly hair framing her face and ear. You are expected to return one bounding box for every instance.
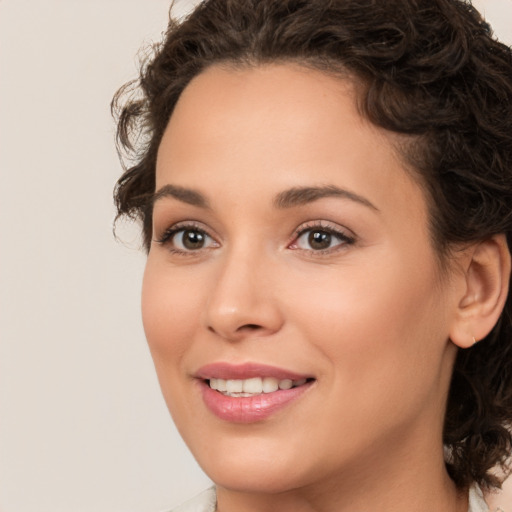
[112,0,512,488]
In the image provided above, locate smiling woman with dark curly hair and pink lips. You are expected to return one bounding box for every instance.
[115,0,512,512]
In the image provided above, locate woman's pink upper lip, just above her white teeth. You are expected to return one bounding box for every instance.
[196,362,312,380]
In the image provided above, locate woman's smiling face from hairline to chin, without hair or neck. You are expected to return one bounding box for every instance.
[142,65,455,492]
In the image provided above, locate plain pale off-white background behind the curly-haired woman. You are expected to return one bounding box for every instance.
[0,0,512,512]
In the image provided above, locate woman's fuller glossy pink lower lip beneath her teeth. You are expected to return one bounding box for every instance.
[201,381,312,423]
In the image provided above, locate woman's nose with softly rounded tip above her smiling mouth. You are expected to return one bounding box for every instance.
[203,252,283,341]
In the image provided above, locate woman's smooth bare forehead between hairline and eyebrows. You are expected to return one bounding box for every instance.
[157,64,425,230]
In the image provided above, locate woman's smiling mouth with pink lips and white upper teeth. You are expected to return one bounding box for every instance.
[196,363,315,423]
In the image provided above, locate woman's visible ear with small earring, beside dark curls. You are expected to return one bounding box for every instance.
[450,235,511,348]
